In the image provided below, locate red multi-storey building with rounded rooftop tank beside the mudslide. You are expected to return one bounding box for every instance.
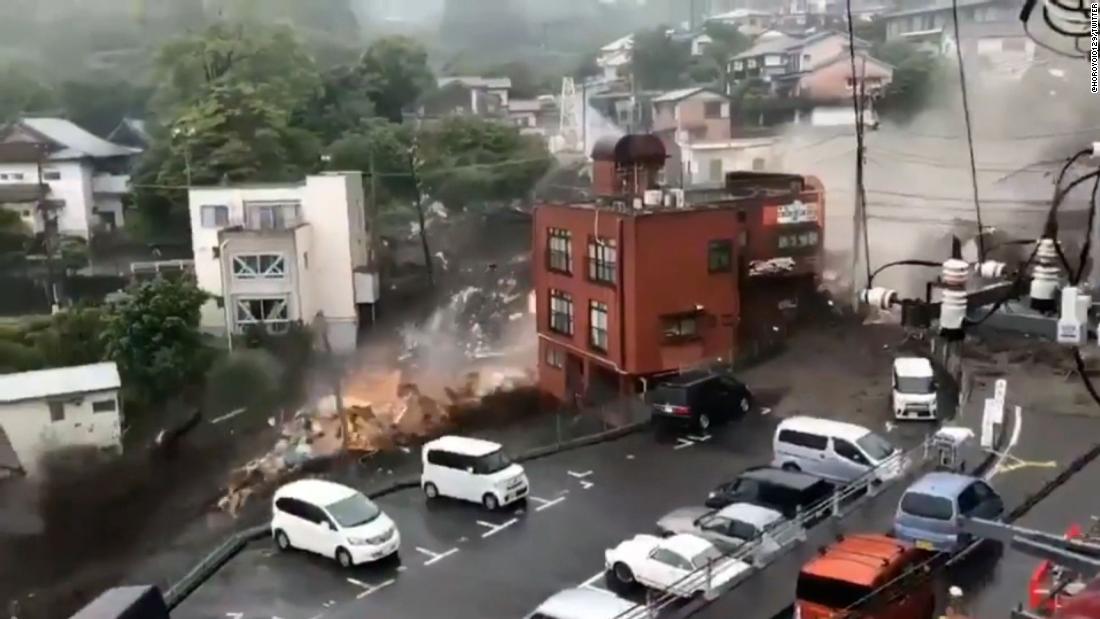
[532,135,824,401]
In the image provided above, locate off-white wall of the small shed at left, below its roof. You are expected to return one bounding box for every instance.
[0,390,122,474]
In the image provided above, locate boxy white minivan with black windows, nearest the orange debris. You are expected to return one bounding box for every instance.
[420,436,528,510]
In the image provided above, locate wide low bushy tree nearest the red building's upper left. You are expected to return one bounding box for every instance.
[419,117,553,210]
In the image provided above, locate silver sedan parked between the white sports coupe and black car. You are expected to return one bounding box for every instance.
[657,502,793,562]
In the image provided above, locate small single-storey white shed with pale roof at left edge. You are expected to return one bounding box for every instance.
[0,362,122,475]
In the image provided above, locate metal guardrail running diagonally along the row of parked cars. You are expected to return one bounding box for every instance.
[615,434,933,619]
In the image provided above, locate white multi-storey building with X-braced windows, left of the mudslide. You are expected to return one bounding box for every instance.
[189,172,378,352]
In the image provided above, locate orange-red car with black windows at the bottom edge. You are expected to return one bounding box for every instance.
[794,534,936,619]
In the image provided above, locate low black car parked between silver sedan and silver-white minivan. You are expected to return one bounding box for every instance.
[706,466,834,526]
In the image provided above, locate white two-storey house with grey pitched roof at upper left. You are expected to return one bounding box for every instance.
[0,118,141,239]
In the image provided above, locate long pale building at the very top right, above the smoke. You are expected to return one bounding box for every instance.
[883,0,1023,45]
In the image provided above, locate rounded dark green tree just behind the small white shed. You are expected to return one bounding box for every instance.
[103,278,208,404]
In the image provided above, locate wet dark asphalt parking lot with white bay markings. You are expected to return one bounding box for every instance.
[176,406,927,619]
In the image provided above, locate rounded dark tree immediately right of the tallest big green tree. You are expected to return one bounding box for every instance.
[359,36,435,122]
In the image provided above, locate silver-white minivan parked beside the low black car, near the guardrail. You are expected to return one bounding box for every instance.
[772,417,902,484]
